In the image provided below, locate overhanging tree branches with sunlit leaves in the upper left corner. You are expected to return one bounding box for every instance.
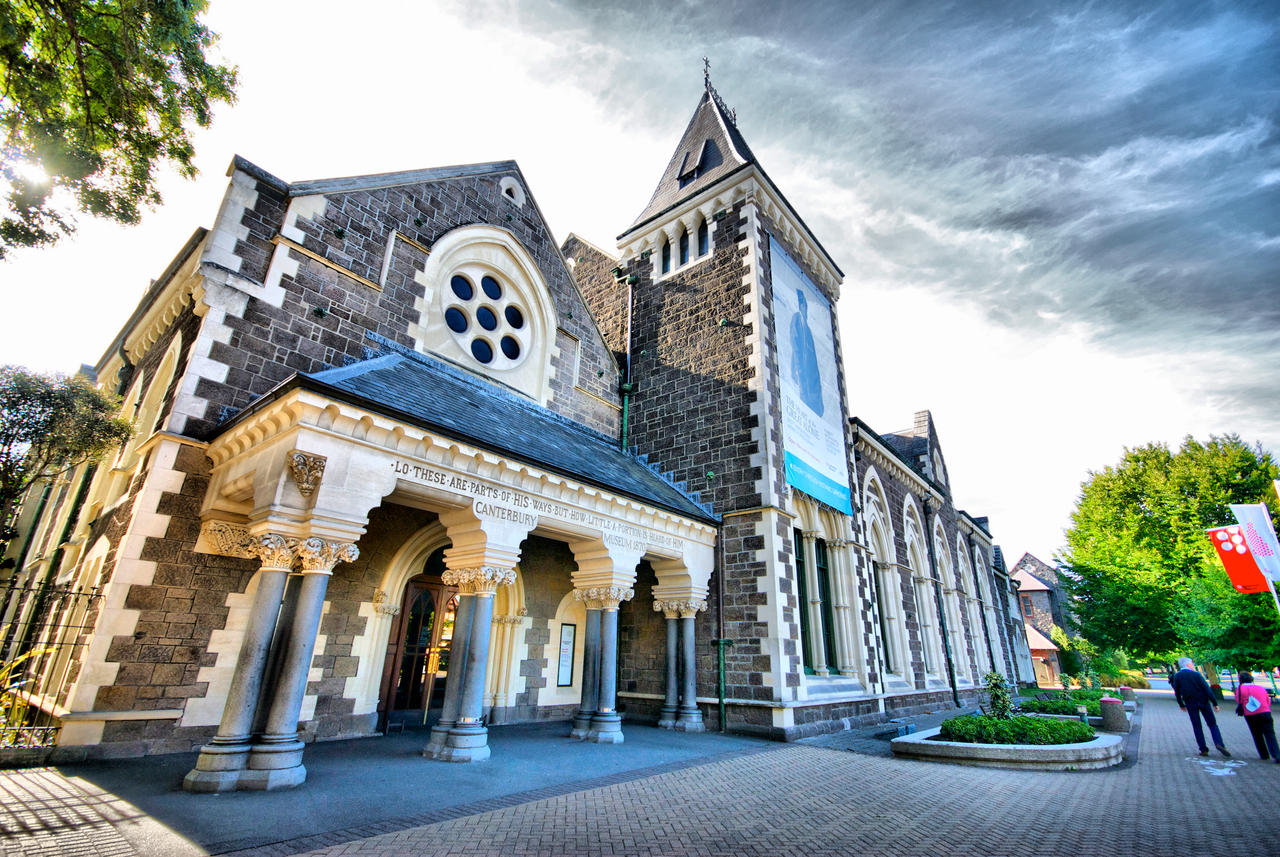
[0,0,236,258]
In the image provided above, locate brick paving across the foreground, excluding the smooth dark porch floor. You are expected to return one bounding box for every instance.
[0,693,1280,857]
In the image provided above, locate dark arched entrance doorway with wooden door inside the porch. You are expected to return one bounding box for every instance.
[378,547,458,730]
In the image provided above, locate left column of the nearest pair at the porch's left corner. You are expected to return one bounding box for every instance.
[182,534,297,792]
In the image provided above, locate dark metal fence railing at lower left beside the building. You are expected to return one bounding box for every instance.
[0,579,102,748]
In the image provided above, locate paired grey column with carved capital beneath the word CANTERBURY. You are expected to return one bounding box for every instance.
[431,565,516,762]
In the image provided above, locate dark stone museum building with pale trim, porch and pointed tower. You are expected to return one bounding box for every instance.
[0,82,1034,792]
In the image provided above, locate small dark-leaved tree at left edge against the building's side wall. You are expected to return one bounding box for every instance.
[0,366,133,534]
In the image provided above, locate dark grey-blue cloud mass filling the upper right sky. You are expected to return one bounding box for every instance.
[478,0,1280,429]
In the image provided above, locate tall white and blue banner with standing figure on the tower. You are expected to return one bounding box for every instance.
[769,235,852,514]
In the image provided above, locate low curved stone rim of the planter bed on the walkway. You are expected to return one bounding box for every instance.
[890,728,1124,771]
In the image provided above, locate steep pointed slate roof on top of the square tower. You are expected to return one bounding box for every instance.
[623,84,755,234]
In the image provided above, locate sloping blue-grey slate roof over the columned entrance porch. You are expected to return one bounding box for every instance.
[220,343,719,523]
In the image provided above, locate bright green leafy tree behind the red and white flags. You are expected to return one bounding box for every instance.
[1064,435,1280,663]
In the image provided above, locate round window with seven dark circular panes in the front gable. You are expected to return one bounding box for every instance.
[444,269,530,368]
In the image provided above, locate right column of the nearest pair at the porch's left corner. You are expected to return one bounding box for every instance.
[241,536,360,790]
